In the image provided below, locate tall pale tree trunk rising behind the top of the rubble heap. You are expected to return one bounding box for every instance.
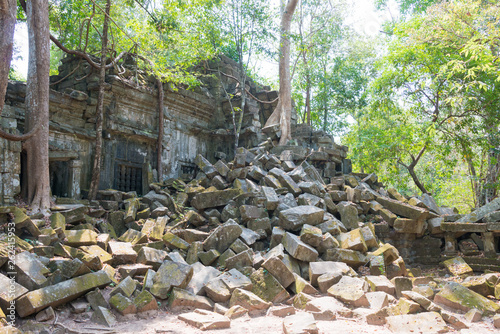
[264,0,299,145]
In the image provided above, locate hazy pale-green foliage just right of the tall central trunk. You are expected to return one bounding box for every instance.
[292,0,374,134]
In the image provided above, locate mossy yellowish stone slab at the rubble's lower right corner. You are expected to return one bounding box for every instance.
[434,282,500,316]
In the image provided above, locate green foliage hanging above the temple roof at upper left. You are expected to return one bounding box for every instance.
[50,0,221,86]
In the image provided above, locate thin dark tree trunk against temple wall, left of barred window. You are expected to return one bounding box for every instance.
[88,0,111,200]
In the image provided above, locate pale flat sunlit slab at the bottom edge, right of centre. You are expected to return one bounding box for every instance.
[386,312,448,333]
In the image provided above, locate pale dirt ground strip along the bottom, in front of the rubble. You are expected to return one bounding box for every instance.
[19,307,500,334]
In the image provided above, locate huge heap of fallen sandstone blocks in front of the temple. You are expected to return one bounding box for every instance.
[0,148,500,333]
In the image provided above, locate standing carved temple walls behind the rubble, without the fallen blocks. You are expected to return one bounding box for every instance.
[0,57,349,204]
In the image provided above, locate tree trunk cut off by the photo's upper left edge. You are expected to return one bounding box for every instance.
[0,0,17,114]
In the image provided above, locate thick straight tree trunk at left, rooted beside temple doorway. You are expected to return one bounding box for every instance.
[24,0,50,211]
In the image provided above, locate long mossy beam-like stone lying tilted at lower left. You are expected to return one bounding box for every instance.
[16,271,111,318]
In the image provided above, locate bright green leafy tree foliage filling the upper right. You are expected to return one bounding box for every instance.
[346,1,500,211]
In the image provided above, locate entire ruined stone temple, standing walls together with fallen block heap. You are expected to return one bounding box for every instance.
[0,58,500,333]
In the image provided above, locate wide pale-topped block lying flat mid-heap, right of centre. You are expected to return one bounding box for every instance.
[279,205,325,231]
